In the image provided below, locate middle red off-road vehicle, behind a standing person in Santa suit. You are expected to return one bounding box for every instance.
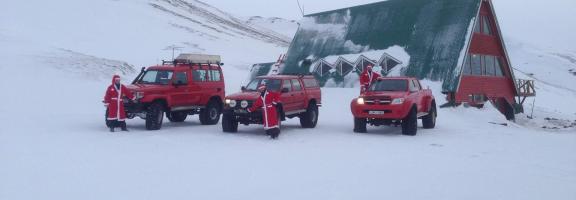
[222,75,322,132]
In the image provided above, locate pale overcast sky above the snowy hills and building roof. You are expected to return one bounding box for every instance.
[202,0,576,51]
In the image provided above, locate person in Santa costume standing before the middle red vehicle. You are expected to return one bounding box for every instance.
[248,85,280,139]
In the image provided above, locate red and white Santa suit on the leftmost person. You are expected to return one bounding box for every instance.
[104,75,135,122]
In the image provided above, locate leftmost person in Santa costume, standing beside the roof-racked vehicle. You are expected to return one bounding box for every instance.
[103,75,136,132]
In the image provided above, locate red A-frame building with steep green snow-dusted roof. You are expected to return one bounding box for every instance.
[281,0,533,118]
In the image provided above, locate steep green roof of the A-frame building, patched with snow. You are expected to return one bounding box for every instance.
[282,0,481,91]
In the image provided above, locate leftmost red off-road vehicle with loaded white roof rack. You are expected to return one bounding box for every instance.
[120,54,224,130]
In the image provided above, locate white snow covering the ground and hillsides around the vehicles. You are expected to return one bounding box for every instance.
[0,0,576,200]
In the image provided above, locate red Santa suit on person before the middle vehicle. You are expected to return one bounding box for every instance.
[248,91,280,130]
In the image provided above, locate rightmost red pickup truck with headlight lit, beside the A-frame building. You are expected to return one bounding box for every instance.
[350,77,437,136]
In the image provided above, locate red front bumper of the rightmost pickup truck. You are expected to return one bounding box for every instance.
[350,102,410,120]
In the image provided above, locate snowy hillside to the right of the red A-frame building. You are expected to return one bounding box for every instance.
[506,37,576,131]
